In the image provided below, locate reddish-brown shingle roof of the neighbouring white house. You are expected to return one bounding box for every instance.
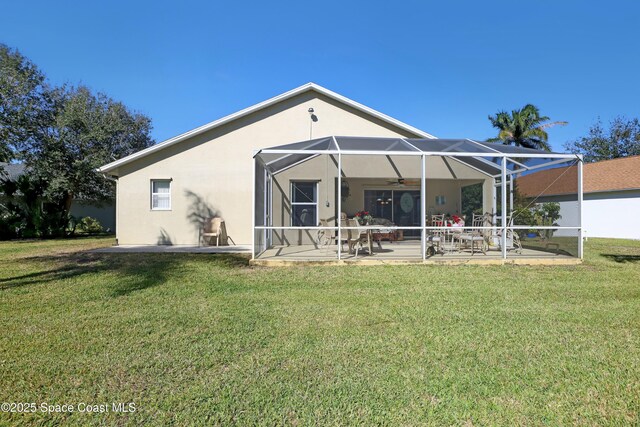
[516,156,640,197]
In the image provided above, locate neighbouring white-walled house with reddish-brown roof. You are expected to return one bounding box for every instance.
[516,156,640,239]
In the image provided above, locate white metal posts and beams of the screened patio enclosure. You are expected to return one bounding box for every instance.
[252,136,583,260]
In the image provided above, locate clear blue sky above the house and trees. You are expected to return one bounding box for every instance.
[0,0,640,150]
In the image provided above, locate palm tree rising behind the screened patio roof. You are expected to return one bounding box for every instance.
[487,104,567,151]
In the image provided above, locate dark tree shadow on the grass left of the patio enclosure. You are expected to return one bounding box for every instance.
[0,252,248,297]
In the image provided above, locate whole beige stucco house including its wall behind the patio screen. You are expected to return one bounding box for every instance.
[98,83,577,259]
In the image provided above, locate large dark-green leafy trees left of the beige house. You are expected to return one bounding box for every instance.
[0,44,154,238]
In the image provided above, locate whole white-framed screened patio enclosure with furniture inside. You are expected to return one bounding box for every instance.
[253,136,582,262]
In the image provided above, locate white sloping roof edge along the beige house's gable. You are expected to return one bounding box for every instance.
[97,83,435,172]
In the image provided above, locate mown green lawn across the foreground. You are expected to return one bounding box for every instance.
[0,238,640,425]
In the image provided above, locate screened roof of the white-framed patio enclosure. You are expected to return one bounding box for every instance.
[255,136,578,177]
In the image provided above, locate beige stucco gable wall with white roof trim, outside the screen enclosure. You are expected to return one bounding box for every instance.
[99,83,490,245]
